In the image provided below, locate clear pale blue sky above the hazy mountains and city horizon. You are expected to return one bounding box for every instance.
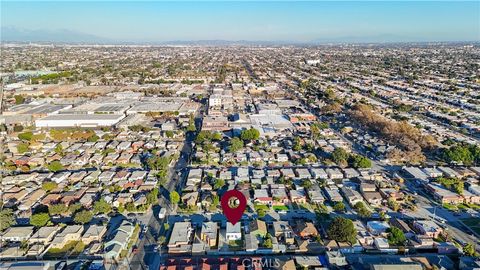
[1,0,480,42]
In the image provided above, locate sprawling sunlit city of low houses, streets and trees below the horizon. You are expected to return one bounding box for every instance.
[0,2,480,270]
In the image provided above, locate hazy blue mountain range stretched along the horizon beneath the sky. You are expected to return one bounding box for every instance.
[0,27,478,46]
